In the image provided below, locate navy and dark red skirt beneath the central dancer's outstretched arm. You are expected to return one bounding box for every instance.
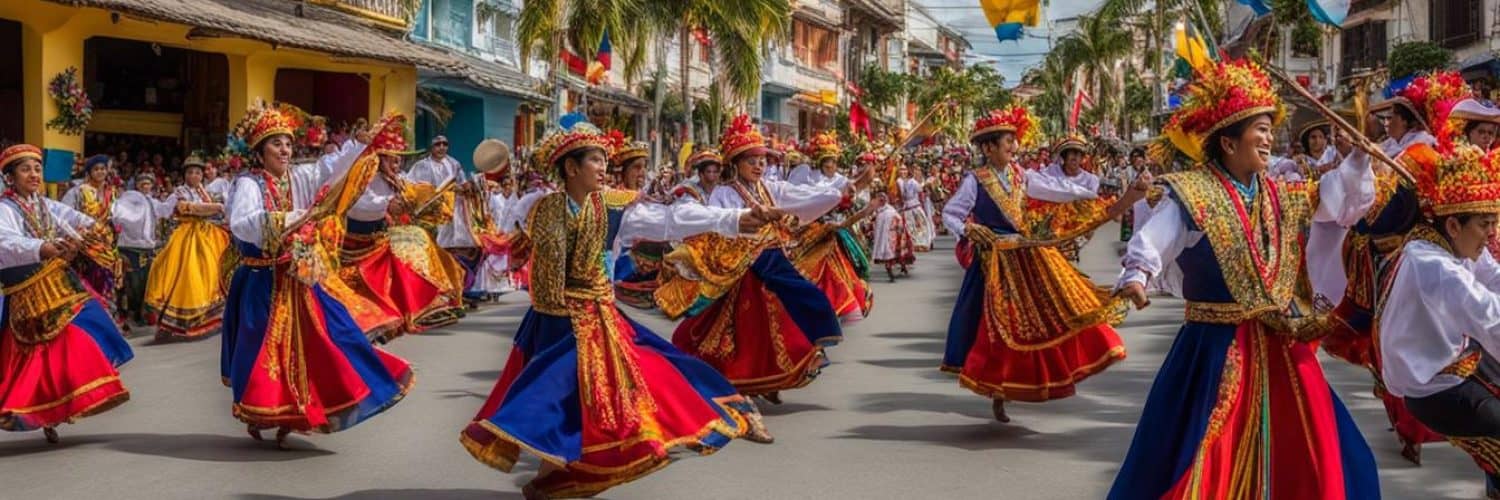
[672,249,843,395]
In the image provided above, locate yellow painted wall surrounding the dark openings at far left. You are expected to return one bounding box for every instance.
[0,0,417,157]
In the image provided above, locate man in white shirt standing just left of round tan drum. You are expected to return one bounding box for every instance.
[407,135,483,308]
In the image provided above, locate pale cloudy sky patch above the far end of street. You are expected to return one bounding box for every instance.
[915,0,1101,87]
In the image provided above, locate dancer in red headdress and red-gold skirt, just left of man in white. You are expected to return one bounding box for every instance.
[339,126,465,344]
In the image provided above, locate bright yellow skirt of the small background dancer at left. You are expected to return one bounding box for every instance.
[146,219,230,339]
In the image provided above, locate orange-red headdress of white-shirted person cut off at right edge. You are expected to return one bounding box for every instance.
[1401,144,1500,216]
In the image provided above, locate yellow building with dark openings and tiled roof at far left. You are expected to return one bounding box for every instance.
[0,0,498,182]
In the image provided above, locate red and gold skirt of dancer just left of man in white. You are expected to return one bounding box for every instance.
[339,225,465,341]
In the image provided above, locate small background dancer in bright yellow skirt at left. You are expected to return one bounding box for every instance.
[146,156,234,341]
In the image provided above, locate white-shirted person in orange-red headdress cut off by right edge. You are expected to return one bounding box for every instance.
[1377,135,1500,498]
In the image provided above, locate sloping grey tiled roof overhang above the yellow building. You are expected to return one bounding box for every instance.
[48,0,474,75]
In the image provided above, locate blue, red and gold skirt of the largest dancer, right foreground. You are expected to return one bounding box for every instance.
[1109,321,1380,500]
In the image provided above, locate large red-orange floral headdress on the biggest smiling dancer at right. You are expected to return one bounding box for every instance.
[1161,60,1287,162]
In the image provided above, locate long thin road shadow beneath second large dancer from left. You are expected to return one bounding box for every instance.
[101,431,333,462]
